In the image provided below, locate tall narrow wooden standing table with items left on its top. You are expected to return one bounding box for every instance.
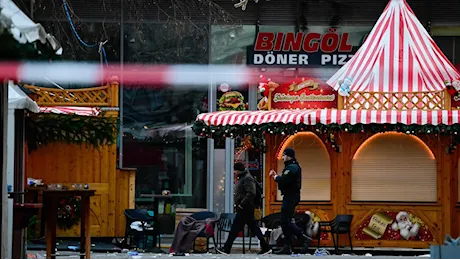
[43,189,96,260]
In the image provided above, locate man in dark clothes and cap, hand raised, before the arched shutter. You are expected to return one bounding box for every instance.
[270,148,311,255]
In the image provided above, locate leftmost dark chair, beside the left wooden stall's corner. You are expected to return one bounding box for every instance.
[124,209,158,249]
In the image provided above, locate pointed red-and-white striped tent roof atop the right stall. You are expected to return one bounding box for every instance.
[327,0,460,92]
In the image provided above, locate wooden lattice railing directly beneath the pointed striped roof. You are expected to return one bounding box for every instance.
[339,91,451,110]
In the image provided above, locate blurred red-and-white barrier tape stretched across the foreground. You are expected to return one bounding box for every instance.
[0,62,337,89]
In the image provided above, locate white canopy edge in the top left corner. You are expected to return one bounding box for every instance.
[0,0,62,55]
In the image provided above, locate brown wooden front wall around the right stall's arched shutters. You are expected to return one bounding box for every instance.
[265,133,460,248]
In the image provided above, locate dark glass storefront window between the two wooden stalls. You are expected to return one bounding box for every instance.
[123,24,208,209]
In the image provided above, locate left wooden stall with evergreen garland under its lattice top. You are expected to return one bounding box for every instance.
[23,78,135,237]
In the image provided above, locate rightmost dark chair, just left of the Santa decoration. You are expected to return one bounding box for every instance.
[318,215,353,254]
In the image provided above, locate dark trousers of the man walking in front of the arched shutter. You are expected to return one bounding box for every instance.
[281,194,303,245]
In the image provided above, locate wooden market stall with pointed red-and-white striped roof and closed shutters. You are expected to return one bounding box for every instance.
[194,0,460,248]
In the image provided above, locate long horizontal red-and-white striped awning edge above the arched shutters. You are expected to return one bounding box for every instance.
[197,109,460,126]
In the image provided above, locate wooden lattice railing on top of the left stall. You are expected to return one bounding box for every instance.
[24,81,118,107]
